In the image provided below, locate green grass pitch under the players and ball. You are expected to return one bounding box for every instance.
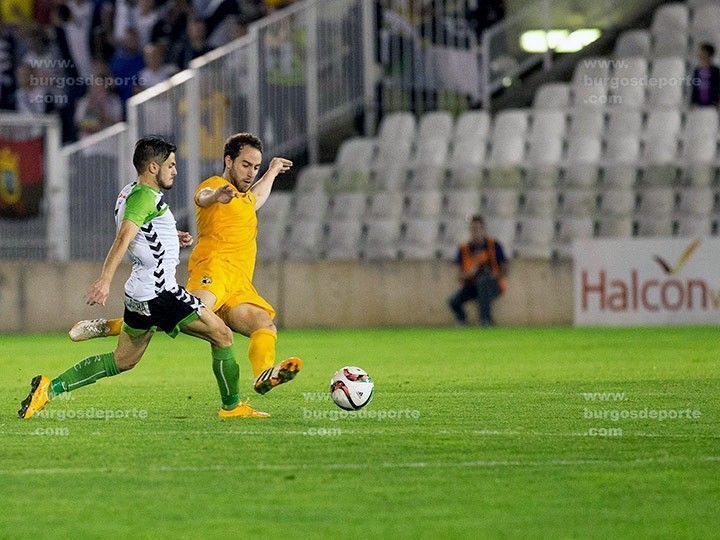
[0,327,720,539]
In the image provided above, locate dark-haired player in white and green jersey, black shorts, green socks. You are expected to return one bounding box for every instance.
[18,137,269,418]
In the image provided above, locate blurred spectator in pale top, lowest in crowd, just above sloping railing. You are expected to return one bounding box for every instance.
[75,60,122,138]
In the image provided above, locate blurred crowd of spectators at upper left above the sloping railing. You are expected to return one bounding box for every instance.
[0,0,294,143]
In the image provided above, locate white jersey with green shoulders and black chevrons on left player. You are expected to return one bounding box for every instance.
[115,182,180,301]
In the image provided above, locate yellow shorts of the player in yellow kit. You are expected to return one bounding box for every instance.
[185,261,275,319]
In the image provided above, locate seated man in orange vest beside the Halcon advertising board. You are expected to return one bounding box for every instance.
[448,215,507,326]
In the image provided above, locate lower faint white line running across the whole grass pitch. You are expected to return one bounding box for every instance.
[0,456,720,476]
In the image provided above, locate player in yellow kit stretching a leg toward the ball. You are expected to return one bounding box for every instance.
[70,133,302,394]
